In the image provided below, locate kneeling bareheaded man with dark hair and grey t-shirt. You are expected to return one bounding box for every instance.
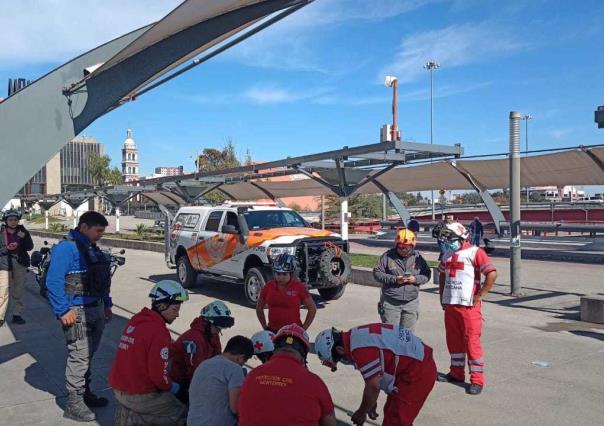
[187,336,254,426]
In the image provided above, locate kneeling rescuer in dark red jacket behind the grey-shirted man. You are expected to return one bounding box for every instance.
[170,300,235,403]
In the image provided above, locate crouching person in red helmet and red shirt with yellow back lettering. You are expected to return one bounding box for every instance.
[238,324,336,426]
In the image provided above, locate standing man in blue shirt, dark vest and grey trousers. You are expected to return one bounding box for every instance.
[46,211,112,422]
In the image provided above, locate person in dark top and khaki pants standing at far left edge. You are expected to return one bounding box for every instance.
[0,210,34,327]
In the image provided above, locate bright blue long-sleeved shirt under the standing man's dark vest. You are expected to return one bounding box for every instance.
[46,229,113,317]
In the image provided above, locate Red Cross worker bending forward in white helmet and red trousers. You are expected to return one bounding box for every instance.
[315,323,436,426]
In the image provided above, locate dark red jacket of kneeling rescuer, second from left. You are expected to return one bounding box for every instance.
[170,317,222,384]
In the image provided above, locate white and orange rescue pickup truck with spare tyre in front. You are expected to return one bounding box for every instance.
[168,205,351,305]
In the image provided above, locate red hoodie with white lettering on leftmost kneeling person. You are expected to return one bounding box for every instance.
[109,308,172,394]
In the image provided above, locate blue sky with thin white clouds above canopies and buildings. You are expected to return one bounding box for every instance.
[0,0,604,192]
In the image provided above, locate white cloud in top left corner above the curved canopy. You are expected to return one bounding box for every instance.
[0,0,180,68]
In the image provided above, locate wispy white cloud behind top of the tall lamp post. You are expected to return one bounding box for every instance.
[378,22,530,83]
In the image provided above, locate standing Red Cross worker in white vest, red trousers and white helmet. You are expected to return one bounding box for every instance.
[438,222,497,395]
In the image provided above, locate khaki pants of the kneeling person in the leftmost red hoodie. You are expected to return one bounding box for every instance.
[113,389,187,426]
